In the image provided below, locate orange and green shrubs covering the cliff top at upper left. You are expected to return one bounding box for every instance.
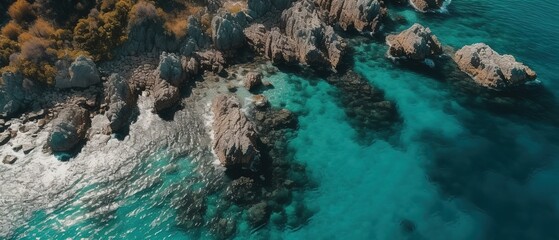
[0,0,207,85]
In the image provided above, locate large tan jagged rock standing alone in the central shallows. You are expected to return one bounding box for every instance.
[212,95,262,171]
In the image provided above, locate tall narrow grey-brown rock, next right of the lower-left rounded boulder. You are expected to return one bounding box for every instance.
[105,73,136,132]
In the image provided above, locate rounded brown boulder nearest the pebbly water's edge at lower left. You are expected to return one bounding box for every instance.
[47,106,91,152]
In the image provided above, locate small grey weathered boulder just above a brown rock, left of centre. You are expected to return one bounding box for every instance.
[156,52,185,86]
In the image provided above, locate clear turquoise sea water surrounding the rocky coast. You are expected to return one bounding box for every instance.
[8,0,559,240]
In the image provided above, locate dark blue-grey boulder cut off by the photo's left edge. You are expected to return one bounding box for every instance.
[0,72,32,117]
